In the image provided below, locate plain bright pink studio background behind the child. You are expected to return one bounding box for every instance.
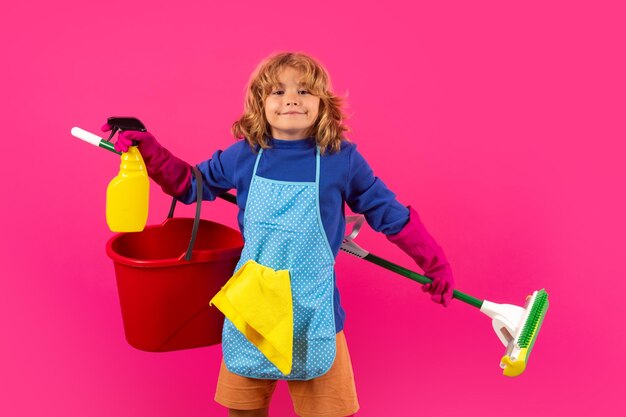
[0,0,626,417]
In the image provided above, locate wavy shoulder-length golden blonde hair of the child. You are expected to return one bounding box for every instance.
[231,52,349,153]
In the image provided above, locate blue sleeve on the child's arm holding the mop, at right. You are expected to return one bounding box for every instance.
[346,145,409,235]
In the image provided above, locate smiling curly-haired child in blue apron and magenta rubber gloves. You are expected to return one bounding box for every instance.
[103,53,454,417]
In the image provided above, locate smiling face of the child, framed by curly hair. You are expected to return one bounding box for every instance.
[265,67,320,140]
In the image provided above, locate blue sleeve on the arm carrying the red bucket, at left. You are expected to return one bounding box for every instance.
[178,142,241,204]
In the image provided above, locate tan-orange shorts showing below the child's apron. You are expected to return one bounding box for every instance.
[215,331,359,417]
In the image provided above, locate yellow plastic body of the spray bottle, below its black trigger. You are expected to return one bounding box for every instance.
[106,146,150,232]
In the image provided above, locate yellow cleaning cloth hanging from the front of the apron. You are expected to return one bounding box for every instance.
[210,260,293,375]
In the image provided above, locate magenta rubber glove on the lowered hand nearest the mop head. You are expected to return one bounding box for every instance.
[387,206,454,307]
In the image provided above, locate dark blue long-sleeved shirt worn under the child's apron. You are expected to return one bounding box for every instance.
[179,138,409,332]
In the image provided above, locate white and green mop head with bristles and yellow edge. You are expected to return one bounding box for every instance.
[481,289,549,376]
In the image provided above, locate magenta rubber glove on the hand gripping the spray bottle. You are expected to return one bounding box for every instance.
[102,123,191,197]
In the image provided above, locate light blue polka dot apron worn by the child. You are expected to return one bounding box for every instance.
[222,149,336,380]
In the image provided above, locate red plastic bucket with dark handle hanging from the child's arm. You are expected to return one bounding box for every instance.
[106,170,243,352]
